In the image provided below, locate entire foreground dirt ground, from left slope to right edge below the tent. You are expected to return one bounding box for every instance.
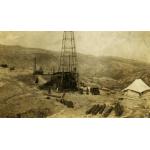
[0,68,150,118]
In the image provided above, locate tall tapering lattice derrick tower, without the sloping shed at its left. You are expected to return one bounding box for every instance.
[58,31,78,90]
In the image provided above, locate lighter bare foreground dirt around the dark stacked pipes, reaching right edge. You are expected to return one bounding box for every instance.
[49,93,150,118]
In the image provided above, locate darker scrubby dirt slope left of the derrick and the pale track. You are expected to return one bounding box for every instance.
[0,68,66,118]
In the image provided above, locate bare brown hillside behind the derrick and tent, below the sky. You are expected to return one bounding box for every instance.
[0,45,150,89]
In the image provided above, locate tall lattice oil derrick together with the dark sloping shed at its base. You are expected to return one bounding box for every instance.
[41,31,79,91]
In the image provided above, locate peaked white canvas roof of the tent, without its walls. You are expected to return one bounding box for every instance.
[123,79,150,93]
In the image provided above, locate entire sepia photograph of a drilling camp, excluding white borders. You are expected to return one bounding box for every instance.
[0,31,150,118]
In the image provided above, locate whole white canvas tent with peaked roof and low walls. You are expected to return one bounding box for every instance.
[123,79,150,97]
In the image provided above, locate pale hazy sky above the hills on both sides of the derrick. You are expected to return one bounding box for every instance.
[0,31,150,62]
